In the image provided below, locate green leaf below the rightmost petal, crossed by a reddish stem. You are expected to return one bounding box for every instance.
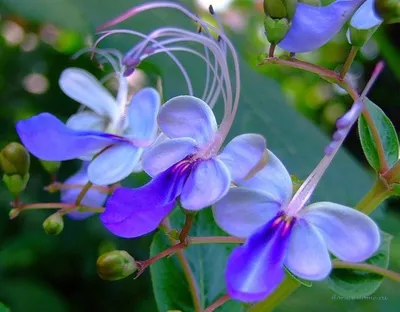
[328,231,393,298]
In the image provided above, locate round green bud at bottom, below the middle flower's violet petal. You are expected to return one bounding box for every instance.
[97,250,137,281]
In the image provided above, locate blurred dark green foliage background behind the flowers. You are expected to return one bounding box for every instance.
[0,0,400,312]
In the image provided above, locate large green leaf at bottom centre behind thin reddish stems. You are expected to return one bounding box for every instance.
[150,209,244,312]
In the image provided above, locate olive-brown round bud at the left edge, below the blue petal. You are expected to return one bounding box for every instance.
[0,142,30,176]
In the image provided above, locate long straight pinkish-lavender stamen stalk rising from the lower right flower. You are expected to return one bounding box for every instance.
[285,62,384,216]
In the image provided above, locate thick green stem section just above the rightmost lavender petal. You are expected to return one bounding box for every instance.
[355,177,392,214]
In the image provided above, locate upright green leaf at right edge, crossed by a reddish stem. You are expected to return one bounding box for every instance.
[358,100,399,171]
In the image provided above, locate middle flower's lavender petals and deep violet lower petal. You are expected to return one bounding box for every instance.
[101,96,266,238]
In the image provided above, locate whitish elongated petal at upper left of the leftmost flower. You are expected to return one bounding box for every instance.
[59,68,118,120]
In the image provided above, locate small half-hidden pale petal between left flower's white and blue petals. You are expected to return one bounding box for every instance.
[65,111,107,131]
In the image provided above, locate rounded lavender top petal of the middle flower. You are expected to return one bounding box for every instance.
[158,95,217,144]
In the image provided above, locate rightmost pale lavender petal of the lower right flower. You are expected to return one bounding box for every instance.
[303,202,380,262]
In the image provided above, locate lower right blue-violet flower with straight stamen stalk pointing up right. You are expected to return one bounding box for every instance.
[213,96,380,302]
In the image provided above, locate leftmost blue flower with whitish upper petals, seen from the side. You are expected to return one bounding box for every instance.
[16,65,160,185]
